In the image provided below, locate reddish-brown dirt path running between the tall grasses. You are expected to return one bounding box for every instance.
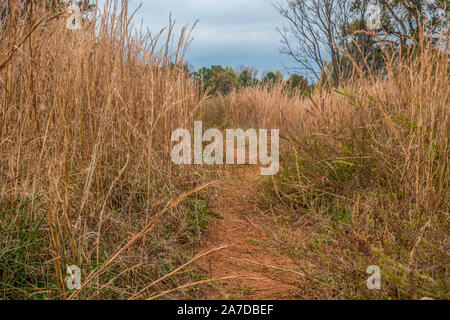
[200,166,301,300]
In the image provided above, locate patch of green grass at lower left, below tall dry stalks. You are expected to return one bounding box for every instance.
[0,198,51,299]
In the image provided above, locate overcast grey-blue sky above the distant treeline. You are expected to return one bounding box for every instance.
[120,0,291,74]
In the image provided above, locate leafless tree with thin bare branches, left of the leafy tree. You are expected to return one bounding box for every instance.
[275,0,352,85]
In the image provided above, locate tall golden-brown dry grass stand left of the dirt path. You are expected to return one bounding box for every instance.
[0,1,214,299]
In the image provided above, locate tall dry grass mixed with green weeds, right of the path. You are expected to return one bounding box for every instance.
[222,28,450,299]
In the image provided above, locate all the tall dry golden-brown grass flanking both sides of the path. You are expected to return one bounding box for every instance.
[0,0,450,299]
